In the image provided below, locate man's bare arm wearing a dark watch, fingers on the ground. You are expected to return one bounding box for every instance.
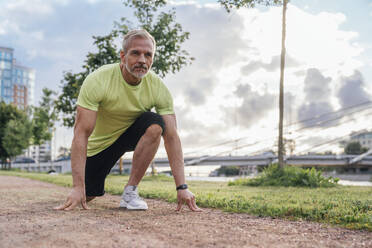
[162,114,201,211]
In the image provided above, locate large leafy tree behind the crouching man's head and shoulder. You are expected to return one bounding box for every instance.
[56,0,194,127]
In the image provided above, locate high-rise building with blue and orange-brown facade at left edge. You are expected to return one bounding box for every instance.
[0,47,35,109]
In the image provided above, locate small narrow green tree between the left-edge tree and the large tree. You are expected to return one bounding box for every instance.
[32,88,57,145]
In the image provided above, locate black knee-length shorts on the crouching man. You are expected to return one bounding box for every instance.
[85,112,165,196]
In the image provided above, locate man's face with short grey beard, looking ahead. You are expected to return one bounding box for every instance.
[120,37,154,79]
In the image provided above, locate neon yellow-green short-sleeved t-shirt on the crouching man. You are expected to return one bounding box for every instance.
[77,63,174,157]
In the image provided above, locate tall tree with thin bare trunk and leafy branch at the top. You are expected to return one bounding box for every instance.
[218,0,288,168]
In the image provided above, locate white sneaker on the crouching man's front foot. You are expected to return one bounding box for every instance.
[120,185,148,210]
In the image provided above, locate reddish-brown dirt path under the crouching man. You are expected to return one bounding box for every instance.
[0,176,372,248]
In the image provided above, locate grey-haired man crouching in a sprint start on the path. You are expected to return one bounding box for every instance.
[56,30,200,211]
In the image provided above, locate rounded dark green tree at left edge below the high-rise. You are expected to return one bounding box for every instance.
[0,102,31,162]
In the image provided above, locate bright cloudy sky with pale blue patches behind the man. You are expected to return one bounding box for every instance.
[0,0,372,156]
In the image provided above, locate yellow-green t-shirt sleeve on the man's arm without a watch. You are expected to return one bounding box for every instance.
[77,73,105,111]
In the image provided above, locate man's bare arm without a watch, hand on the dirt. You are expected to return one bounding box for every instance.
[56,106,97,210]
